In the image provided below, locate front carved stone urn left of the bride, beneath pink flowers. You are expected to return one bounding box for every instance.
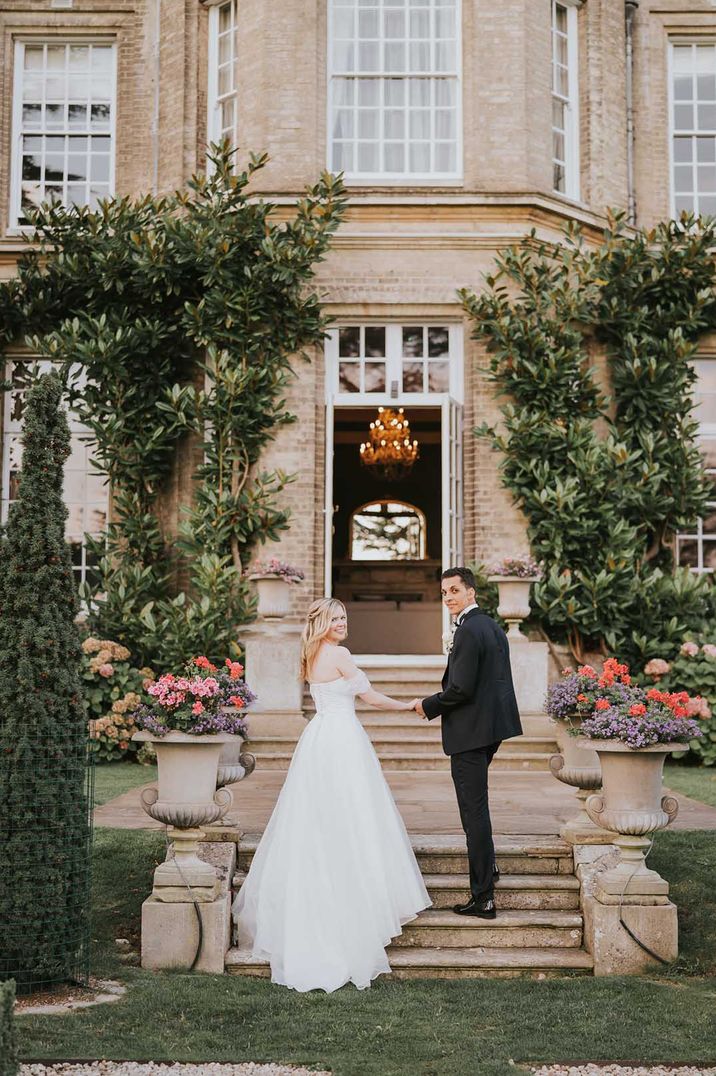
[132,731,238,903]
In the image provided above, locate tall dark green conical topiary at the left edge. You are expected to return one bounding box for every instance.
[0,373,90,990]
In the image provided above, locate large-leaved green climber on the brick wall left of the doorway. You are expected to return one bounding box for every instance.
[0,144,345,666]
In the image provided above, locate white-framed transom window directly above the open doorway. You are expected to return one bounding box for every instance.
[326,318,462,404]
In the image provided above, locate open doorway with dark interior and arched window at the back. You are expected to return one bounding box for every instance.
[331,407,443,654]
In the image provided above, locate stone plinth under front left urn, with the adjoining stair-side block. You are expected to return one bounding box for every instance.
[142,843,236,975]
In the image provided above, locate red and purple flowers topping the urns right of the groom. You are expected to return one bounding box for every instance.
[546,657,708,748]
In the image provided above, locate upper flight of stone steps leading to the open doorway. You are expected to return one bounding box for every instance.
[245,655,558,773]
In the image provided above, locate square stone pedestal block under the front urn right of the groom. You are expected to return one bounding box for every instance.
[582,896,678,975]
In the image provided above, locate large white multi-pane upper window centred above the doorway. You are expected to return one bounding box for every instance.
[327,0,462,184]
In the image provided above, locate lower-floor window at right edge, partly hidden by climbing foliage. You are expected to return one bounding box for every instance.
[676,358,716,572]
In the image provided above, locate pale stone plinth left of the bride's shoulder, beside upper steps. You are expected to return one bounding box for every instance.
[241,620,306,740]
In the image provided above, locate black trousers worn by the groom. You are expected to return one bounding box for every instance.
[450,741,501,901]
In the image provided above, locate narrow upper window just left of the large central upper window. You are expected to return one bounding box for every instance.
[208,0,239,153]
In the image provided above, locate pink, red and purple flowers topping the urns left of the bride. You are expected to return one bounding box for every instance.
[132,655,256,739]
